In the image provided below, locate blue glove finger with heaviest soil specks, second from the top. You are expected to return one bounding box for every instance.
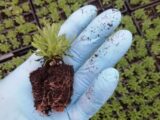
[64,9,121,71]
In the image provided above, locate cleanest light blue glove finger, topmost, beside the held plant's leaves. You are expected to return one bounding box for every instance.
[59,5,97,41]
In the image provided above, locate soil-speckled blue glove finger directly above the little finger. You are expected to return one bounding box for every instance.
[72,30,132,103]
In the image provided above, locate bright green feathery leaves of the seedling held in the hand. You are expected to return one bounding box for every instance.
[32,24,70,59]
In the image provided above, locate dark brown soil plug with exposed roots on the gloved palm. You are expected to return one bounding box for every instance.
[30,60,74,115]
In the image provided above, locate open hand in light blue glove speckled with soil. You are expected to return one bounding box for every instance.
[0,5,132,120]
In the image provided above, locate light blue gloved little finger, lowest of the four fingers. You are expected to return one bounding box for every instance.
[69,68,119,120]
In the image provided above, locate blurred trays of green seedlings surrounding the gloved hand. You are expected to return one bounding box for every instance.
[0,0,160,120]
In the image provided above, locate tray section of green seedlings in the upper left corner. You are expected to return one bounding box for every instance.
[0,0,37,62]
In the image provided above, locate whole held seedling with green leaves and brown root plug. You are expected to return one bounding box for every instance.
[30,23,73,115]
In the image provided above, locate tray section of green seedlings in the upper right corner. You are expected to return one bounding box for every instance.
[132,2,160,71]
